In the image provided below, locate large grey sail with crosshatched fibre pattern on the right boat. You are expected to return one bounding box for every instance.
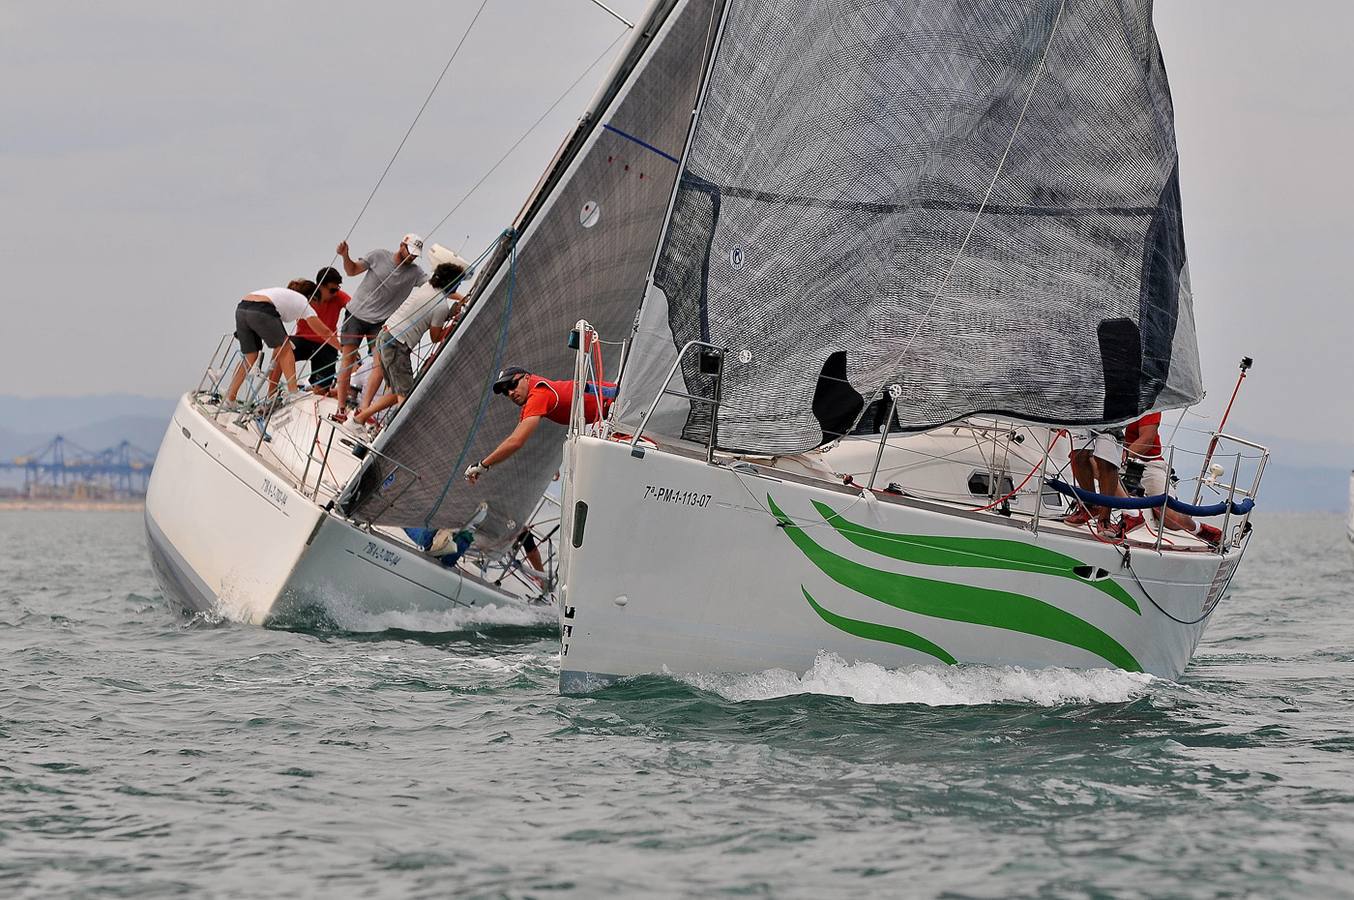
[616,0,1202,453]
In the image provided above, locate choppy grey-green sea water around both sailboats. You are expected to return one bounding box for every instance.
[0,512,1354,897]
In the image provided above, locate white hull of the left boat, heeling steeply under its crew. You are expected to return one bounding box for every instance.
[145,397,524,624]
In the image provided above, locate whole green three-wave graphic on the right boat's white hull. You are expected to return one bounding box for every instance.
[766,494,1143,671]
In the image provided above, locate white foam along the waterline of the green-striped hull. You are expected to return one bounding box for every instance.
[677,652,1156,706]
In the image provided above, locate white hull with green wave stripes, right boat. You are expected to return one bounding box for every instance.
[561,436,1238,692]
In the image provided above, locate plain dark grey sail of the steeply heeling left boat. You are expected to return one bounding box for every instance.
[349,0,712,535]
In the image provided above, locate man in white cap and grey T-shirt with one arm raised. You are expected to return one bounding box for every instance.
[334,234,428,421]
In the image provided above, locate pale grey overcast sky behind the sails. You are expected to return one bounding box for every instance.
[0,0,1354,445]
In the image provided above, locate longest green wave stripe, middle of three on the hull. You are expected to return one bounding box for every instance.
[766,495,1143,671]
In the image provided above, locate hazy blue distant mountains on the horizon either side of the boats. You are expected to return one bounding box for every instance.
[0,394,1354,512]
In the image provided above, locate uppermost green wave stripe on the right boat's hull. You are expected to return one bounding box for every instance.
[814,501,1143,616]
